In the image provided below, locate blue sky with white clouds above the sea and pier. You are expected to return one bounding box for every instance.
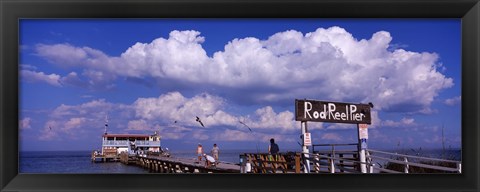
[19,19,461,150]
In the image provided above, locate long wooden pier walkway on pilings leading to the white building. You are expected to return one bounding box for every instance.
[126,156,240,173]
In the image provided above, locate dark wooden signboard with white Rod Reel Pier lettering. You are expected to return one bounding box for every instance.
[295,99,372,124]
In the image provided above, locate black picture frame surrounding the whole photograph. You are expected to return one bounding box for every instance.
[0,0,480,191]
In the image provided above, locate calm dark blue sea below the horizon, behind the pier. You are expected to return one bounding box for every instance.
[19,150,461,174]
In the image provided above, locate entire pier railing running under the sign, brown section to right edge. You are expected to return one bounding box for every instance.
[240,149,462,173]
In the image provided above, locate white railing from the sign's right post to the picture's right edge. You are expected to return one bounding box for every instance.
[367,149,462,173]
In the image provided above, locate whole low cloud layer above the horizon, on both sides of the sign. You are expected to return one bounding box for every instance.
[35,92,444,143]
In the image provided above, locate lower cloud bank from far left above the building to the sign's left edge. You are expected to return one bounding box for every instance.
[42,92,304,140]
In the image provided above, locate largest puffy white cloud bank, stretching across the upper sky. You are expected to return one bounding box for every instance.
[36,27,453,112]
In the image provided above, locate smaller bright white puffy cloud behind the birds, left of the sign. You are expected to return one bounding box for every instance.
[132,92,304,131]
